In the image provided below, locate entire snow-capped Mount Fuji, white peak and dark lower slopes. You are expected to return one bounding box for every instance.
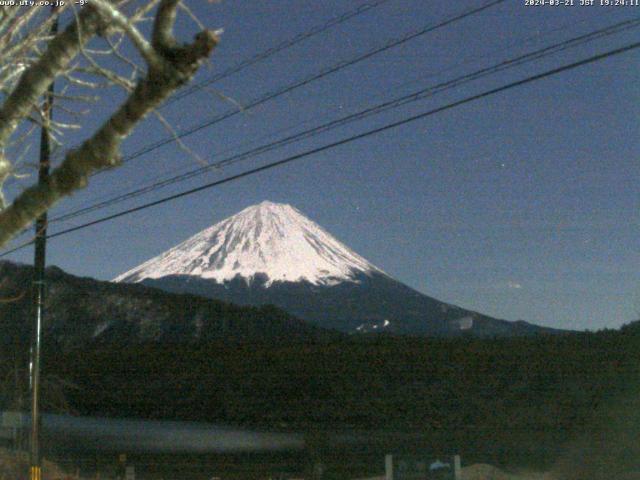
[114,201,555,336]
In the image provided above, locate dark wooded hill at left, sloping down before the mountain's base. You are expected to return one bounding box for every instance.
[0,262,339,350]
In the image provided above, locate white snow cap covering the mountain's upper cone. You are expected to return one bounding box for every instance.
[114,201,384,287]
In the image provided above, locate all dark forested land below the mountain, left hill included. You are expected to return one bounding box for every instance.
[0,263,640,478]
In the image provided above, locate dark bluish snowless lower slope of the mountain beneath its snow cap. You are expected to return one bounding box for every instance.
[141,275,564,337]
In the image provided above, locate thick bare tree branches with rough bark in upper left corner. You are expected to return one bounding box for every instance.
[0,0,218,247]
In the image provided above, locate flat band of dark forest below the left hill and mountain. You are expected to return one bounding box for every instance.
[3,324,640,478]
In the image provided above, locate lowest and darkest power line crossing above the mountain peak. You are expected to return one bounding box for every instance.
[0,42,640,258]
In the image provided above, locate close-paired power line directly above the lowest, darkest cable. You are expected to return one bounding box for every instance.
[50,18,640,227]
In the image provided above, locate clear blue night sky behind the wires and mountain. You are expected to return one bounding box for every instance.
[2,0,640,329]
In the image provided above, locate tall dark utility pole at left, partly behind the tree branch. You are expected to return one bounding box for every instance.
[29,7,58,480]
